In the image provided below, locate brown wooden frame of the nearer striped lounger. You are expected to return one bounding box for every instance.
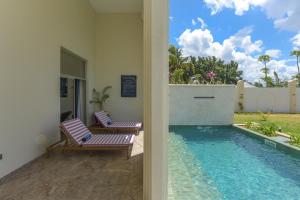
[47,130,133,159]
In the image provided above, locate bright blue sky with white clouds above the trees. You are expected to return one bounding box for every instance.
[169,0,300,82]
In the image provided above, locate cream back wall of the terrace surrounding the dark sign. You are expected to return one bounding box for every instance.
[95,14,143,121]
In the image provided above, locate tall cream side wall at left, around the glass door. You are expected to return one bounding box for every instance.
[0,0,96,177]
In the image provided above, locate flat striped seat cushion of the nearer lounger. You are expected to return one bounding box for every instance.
[82,134,134,146]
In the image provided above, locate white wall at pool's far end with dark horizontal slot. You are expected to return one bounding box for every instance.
[170,85,236,125]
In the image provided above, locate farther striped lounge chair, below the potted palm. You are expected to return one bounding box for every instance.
[94,111,142,135]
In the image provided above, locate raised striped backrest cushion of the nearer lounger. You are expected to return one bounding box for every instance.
[60,119,91,145]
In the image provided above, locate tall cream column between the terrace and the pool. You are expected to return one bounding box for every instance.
[144,0,169,200]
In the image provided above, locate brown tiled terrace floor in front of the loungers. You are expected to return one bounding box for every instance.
[0,133,143,200]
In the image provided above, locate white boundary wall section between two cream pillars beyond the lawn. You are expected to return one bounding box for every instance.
[244,88,290,113]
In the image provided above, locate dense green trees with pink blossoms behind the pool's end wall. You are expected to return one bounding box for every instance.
[169,45,243,84]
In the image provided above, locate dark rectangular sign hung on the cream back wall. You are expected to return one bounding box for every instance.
[121,75,137,97]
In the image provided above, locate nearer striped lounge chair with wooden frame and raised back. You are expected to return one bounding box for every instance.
[47,119,135,159]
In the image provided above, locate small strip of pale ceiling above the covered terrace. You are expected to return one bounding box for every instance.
[90,0,143,13]
